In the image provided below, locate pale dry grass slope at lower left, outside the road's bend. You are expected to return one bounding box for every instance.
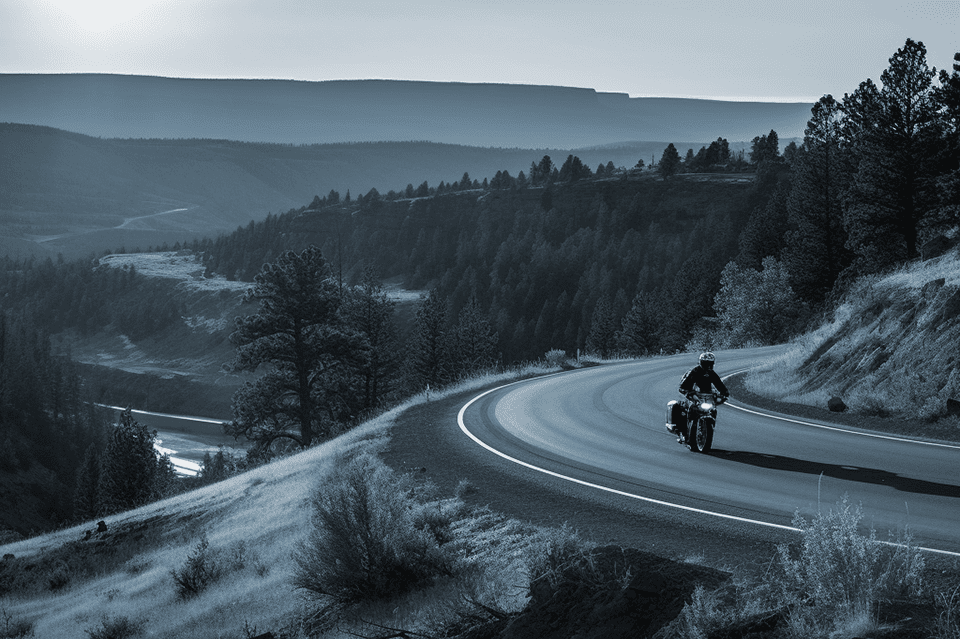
[0,365,556,639]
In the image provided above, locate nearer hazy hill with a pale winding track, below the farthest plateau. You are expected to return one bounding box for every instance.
[0,124,720,257]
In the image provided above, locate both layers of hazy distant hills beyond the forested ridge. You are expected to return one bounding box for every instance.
[0,74,810,257]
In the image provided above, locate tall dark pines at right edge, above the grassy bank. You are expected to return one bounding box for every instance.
[737,40,960,316]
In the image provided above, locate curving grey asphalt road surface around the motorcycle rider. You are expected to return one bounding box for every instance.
[459,347,960,556]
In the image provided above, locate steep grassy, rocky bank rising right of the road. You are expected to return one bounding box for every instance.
[747,249,960,424]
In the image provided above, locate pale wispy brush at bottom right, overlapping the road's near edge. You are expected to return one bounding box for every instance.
[673,499,928,639]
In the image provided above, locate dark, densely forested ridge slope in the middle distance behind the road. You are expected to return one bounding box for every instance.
[198,171,763,362]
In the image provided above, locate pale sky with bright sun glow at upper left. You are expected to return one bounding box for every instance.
[0,0,960,102]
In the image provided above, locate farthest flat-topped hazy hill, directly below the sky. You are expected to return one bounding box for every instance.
[0,74,811,149]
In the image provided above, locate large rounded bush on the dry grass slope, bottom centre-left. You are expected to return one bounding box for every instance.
[294,455,456,606]
